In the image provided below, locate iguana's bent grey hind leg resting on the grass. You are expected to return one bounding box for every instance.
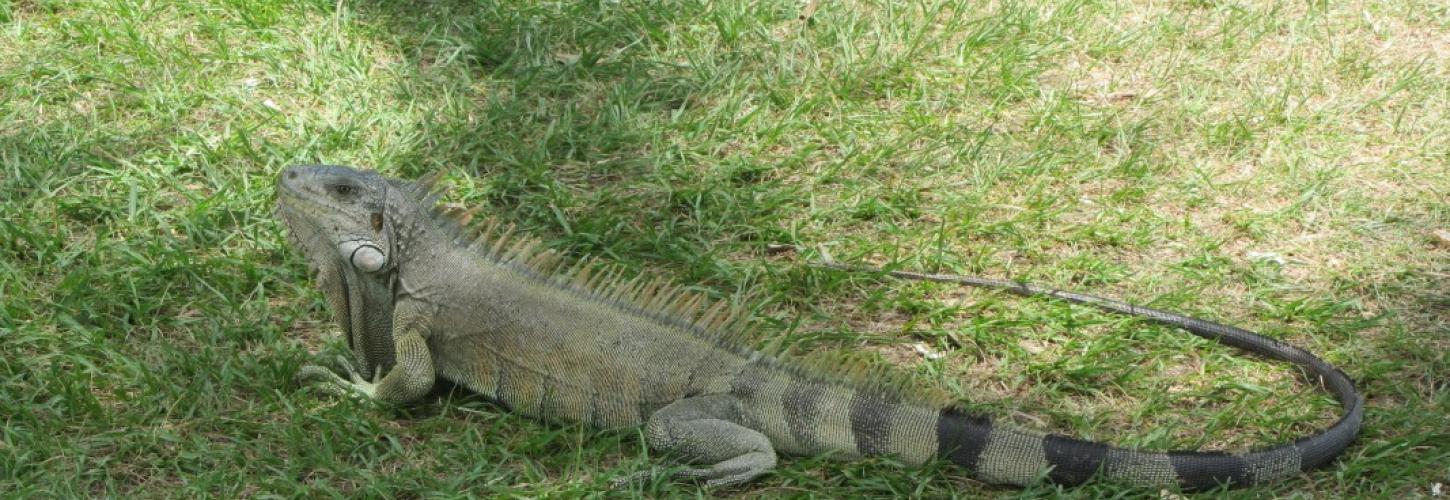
[629,394,776,487]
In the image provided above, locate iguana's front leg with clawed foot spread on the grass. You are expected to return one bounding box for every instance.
[297,304,435,404]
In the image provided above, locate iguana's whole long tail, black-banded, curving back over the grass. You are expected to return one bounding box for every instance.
[732,264,1364,490]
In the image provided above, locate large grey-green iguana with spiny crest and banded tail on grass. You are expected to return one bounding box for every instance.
[277,165,1363,490]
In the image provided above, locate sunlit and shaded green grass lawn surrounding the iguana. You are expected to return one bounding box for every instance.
[0,0,1450,497]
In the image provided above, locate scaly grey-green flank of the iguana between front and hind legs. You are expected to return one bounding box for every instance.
[428,252,748,428]
